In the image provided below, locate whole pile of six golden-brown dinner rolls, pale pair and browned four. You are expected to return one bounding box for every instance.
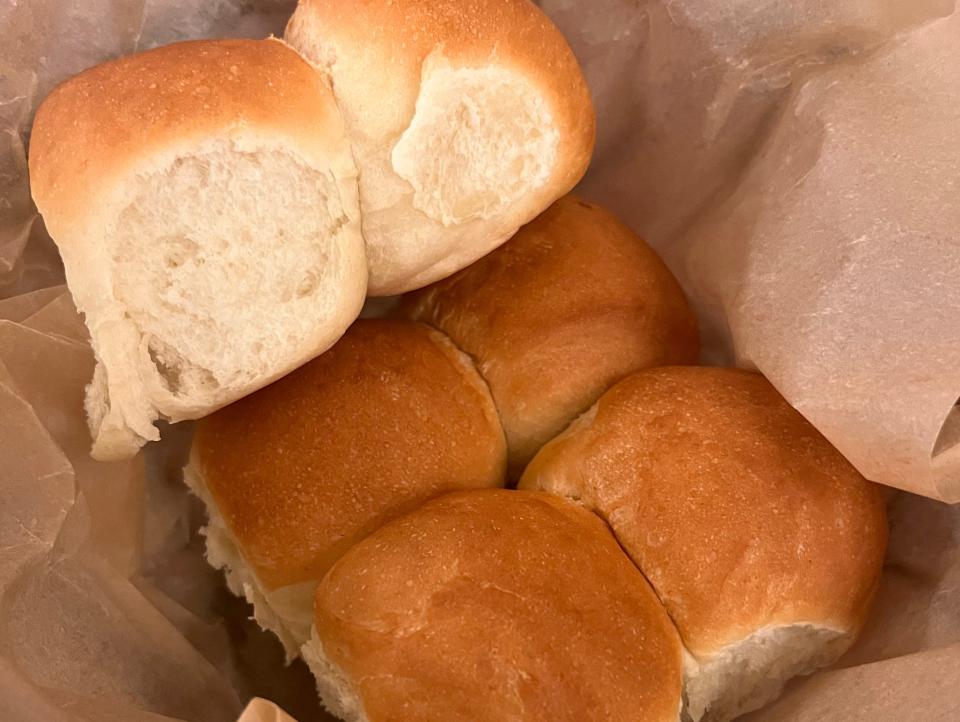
[30,0,886,722]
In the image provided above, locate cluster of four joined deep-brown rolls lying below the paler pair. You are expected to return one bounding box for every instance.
[188,197,886,722]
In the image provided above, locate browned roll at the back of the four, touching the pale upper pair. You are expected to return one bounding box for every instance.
[402,196,698,476]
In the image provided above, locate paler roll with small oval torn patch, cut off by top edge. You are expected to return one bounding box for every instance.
[284,0,594,295]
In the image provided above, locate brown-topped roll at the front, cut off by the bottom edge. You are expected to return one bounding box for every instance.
[303,490,682,722]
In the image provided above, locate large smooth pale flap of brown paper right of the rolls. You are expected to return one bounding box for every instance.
[691,9,960,501]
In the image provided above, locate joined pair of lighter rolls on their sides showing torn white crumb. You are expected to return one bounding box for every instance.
[30,0,595,459]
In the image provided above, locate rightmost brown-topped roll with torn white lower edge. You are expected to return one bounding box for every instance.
[520,367,887,720]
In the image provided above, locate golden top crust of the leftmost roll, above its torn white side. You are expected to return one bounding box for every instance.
[29,38,356,231]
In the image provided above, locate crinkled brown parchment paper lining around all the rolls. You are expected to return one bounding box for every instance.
[0,0,960,722]
